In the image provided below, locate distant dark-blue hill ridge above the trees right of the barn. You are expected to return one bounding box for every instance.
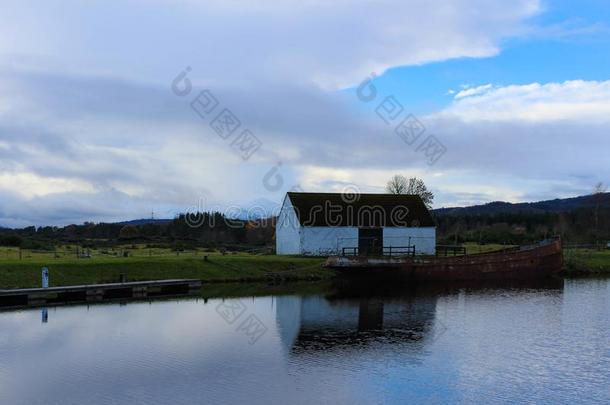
[434,193,610,216]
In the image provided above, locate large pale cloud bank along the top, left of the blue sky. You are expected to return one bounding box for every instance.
[0,0,541,88]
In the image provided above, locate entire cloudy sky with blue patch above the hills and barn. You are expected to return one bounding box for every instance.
[0,0,610,226]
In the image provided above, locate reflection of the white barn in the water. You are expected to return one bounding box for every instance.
[276,282,439,354]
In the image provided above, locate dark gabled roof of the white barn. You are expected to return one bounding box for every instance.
[288,192,434,227]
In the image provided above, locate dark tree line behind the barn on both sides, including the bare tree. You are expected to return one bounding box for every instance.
[0,175,610,249]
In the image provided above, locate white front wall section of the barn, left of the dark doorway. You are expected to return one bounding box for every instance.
[301,226,358,256]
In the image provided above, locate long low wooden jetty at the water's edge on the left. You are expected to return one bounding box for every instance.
[0,279,201,309]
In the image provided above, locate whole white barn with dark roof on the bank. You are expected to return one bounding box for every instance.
[275,192,436,256]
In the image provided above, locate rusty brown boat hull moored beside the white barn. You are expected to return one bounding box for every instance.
[326,240,563,281]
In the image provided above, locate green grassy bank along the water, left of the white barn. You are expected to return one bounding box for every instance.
[0,253,333,288]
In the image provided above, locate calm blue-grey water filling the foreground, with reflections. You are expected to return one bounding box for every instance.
[0,279,610,404]
